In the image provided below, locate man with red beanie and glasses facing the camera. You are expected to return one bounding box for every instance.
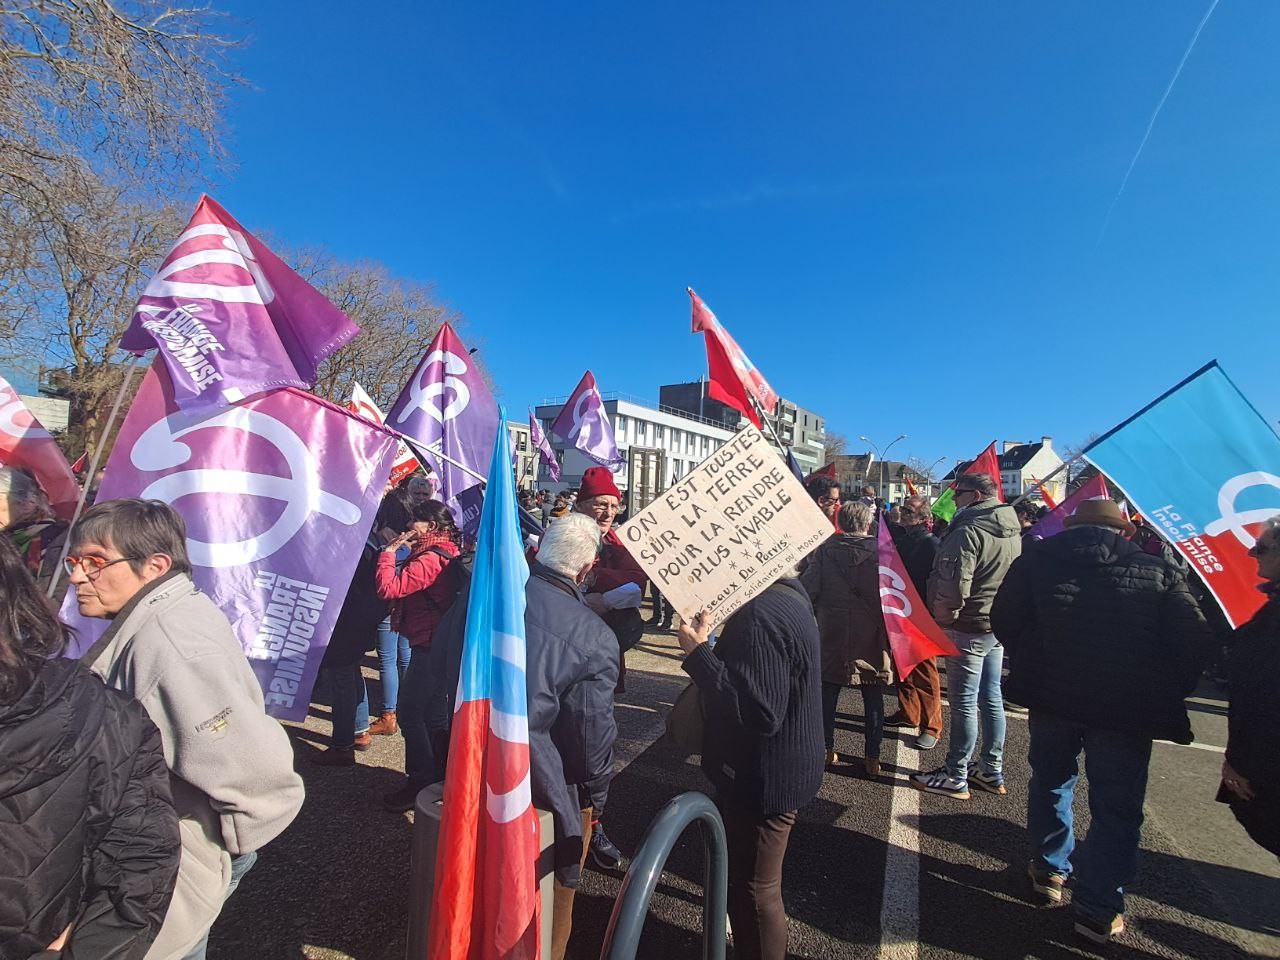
[573,467,649,869]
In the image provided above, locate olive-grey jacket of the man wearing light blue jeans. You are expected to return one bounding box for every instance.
[929,497,1023,634]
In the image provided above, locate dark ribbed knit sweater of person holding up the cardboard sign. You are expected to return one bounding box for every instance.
[684,580,823,817]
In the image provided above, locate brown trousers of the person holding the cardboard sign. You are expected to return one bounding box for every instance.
[716,793,793,960]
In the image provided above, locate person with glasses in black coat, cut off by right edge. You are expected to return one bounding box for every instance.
[1217,516,1280,856]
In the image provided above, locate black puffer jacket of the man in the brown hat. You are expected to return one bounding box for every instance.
[991,526,1212,744]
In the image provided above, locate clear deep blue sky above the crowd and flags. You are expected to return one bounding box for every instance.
[210,0,1280,471]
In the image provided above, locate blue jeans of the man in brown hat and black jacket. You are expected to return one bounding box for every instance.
[1027,710,1151,919]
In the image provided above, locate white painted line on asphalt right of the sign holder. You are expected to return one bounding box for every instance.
[877,740,920,960]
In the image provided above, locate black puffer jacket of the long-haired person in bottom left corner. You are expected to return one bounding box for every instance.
[0,659,179,960]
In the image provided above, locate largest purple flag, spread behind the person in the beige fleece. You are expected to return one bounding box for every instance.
[63,364,397,721]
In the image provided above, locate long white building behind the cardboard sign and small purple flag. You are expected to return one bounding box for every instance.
[534,393,733,512]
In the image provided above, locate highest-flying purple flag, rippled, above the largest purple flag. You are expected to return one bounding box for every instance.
[120,196,360,411]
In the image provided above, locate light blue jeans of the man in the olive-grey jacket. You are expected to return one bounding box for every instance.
[947,630,1005,780]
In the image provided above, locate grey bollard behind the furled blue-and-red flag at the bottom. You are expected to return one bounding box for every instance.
[404,783,556,960]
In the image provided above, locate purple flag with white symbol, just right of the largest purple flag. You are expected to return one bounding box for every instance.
[387,324,498,538]
